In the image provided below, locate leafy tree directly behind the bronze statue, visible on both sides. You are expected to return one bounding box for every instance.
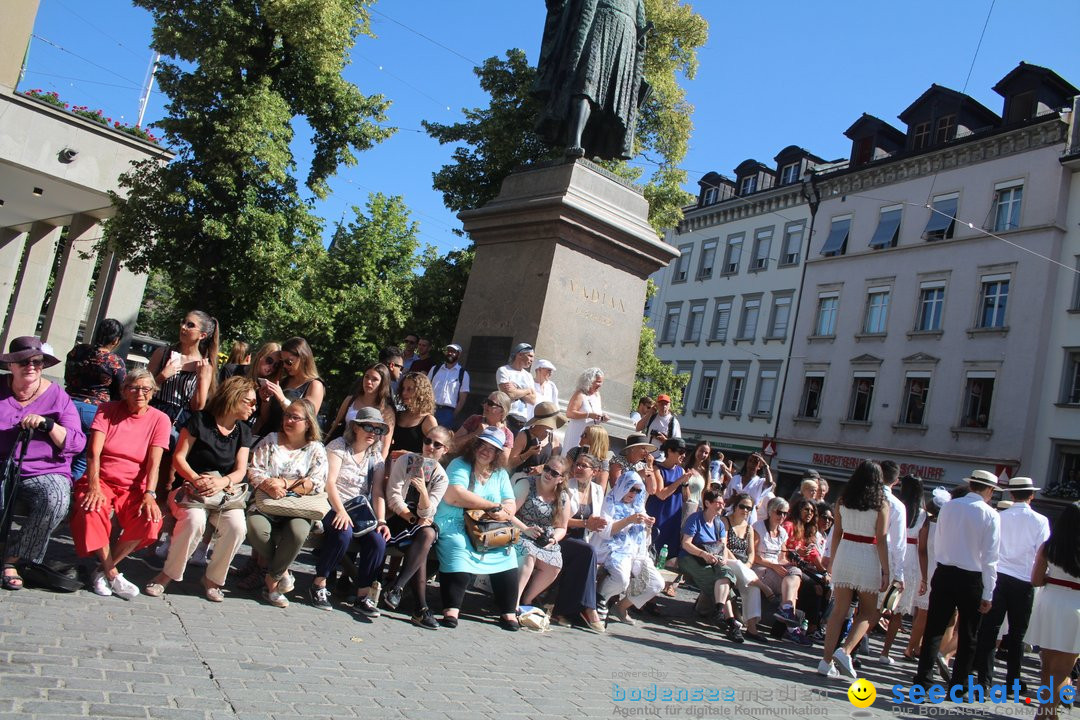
[423,0,708,234]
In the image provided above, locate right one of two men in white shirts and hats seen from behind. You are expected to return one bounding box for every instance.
[975,477,1050,693]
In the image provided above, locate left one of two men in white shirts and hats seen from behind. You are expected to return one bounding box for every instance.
[912,470,1001,699]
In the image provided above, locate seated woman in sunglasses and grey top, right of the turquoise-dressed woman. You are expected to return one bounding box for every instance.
[513,455,570,606]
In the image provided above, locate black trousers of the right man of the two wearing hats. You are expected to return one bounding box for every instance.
[975,574,1035,685]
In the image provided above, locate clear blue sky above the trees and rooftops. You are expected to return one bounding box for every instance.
[21,0,1080,259]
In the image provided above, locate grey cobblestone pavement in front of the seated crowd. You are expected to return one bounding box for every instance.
[0,537,1034,720]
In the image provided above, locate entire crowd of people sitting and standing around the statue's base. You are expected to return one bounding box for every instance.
[0,319,1080,714]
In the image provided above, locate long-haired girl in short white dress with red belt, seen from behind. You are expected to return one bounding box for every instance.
[818,460,890,678]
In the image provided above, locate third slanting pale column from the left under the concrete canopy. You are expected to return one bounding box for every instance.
[41,215,102,353]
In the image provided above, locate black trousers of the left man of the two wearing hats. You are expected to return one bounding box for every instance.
[912,565,983,685]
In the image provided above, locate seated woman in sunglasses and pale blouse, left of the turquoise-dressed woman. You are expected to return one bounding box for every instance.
[382,425,454,630]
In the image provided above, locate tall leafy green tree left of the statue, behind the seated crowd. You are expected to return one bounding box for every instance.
[103,0,392,337]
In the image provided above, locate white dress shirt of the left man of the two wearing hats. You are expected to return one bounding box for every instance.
[934,492,1001,602]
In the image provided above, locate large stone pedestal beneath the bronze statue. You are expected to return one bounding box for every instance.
[454,160,678,431]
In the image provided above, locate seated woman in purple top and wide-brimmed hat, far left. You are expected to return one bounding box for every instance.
[0,337,86,590]
